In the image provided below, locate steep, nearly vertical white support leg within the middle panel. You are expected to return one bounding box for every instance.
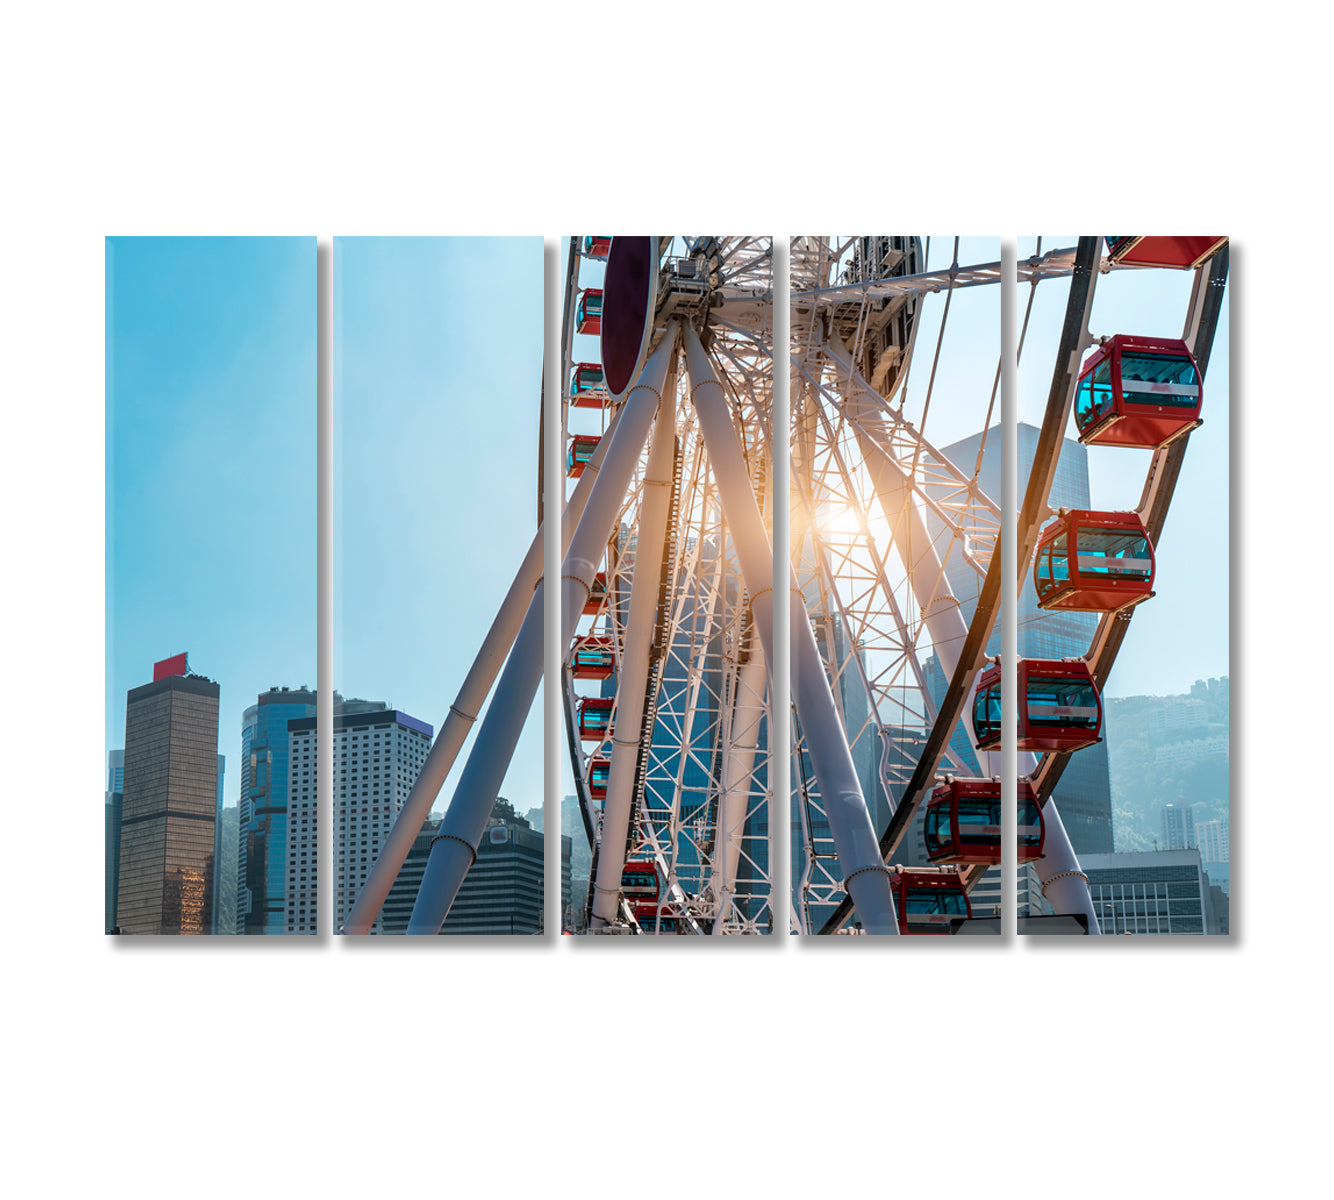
[588,378,676,931]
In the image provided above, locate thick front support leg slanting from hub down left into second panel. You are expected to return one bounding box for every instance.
[408,332,676,933]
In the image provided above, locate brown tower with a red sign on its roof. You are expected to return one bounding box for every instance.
[116,655,219,933]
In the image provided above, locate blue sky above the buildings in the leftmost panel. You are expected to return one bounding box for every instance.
[105,237,315,804]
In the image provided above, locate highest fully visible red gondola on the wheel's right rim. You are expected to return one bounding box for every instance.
[1075,333,1205,449]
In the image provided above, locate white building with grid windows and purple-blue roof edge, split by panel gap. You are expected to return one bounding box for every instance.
[281,700,434,933]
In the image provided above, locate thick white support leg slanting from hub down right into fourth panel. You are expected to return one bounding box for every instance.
[683,325,898,933]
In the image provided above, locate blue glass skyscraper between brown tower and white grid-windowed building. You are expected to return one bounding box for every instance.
[236,684,315,933]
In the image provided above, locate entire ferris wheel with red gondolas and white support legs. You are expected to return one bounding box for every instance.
[338,235,1227,935]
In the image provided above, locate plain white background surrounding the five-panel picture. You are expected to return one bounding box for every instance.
[0,3,1330,1200]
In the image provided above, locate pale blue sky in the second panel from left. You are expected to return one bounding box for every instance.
[334,237,543,812]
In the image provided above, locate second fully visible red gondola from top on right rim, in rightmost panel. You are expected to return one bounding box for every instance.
[1033,508,1154,612]
